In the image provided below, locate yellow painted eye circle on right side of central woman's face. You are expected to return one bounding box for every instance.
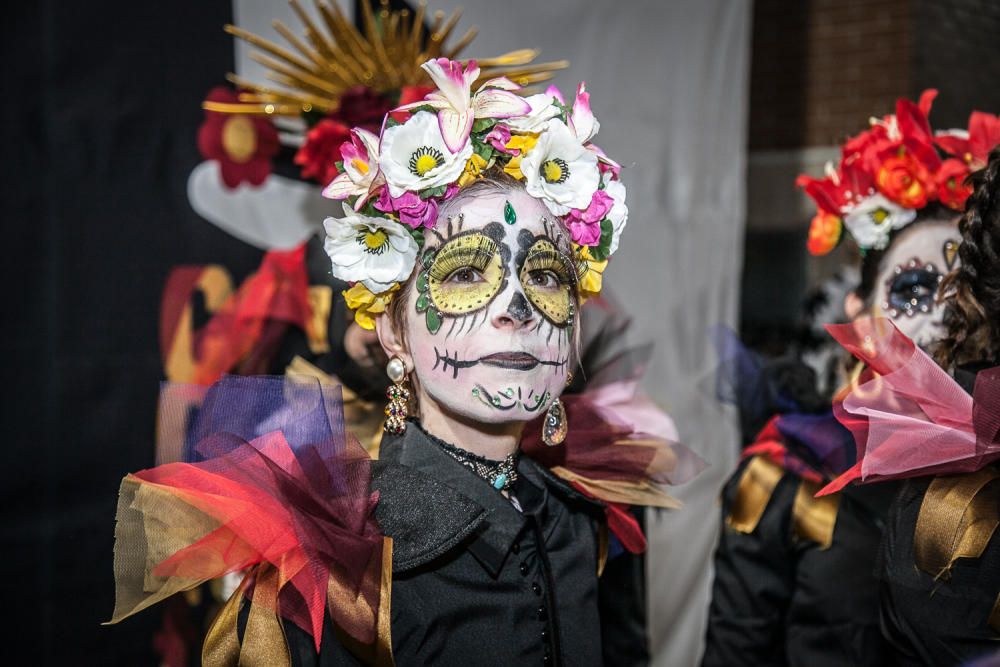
[519,239,576,326]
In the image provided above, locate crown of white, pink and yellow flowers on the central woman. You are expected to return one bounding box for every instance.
[323,58,628,329]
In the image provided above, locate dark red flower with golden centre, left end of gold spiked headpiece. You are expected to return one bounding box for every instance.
[198,86,280,188]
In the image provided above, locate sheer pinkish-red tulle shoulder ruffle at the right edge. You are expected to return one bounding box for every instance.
[819,318,1000,495]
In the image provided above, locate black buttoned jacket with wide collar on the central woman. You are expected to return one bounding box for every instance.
[285,422,604,667]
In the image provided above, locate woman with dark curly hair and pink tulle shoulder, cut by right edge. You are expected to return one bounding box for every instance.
[816,145,1000,665]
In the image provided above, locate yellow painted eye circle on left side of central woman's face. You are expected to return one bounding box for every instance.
[427,232,504,315]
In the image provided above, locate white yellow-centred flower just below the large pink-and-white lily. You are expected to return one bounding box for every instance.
[378,111,472,197]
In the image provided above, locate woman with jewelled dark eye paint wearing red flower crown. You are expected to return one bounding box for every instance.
[703,91,992,665]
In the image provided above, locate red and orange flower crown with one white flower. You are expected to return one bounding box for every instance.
[795,90,1000,255]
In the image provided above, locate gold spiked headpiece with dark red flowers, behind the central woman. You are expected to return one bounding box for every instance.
[198,0,568,189]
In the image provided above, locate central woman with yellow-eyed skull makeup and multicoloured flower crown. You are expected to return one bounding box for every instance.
[103,58,701,665]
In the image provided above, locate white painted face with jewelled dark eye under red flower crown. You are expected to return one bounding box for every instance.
[873,216,961,348]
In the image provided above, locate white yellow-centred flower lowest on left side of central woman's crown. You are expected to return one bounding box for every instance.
[323,204,417,294]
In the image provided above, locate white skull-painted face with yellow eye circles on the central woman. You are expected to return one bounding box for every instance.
[406,189,577,423]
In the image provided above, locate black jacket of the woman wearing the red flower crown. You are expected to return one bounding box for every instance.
[702,459,894,667]
